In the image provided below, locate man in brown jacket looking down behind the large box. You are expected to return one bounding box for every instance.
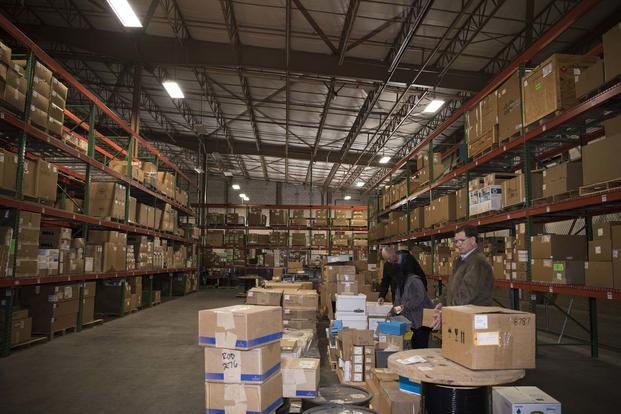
[433,225,494,329]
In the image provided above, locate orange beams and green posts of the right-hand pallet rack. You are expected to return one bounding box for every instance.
[369,1,621,357]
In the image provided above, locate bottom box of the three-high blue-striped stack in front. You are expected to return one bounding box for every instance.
[205,373,283,413]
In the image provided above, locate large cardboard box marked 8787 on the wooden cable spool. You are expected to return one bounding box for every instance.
[442,305,536,369]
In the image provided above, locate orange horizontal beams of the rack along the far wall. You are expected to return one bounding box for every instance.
[193,204,368,269]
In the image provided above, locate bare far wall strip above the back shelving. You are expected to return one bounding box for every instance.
[207,177,367,205]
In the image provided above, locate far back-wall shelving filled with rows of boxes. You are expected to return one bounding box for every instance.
[201,204,368,269]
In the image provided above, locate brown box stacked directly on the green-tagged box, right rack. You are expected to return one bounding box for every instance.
[531,234,587,261]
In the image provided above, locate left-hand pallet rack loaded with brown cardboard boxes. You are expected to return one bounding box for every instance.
[0,18,200,355]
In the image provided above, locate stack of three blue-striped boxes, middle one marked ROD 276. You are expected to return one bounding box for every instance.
[198,305,283,413]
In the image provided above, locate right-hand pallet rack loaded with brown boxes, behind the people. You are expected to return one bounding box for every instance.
[369,17,621,356]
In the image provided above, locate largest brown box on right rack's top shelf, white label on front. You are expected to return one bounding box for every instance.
[522,53,597,125]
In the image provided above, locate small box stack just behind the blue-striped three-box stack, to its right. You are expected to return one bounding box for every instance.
[282,289,319,330]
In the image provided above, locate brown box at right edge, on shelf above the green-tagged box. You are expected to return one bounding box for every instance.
[582,116,621,185]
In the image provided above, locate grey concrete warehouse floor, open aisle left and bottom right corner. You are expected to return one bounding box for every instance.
[0,289,621,414]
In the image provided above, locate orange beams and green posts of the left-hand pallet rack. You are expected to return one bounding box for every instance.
[0,16,197,356]
